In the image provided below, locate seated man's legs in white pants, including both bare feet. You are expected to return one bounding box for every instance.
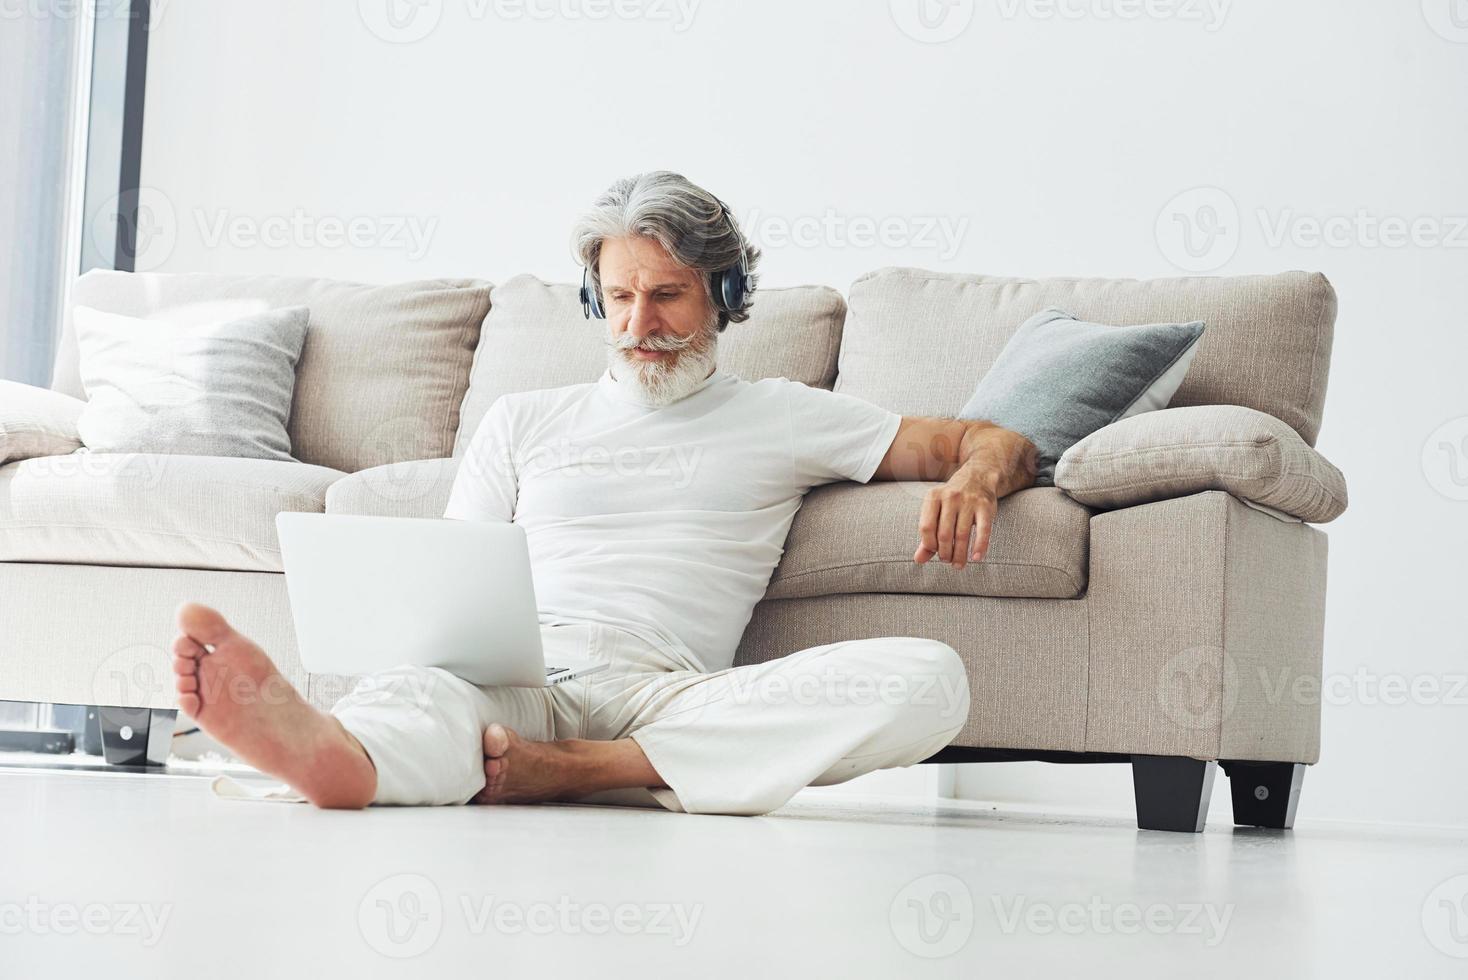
[173,604,969,814]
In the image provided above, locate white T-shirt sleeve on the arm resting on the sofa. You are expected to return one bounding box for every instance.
[785,381,903,487]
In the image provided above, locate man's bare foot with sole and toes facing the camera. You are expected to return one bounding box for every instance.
[173,603,377,810]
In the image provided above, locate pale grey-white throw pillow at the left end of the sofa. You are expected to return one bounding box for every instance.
[72,307,310,461]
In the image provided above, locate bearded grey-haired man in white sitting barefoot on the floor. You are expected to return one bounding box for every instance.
[173,172,1035,814]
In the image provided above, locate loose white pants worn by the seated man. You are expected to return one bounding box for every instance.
[332,624,969,814]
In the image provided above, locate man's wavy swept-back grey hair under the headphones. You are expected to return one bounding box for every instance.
[571,170,759,332]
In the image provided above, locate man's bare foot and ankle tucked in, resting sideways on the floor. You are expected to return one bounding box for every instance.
[471,725,666,804]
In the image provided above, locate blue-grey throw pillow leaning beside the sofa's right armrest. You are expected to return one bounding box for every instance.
[959,310,1204,486]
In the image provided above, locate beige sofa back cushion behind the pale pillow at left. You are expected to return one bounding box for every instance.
[51,271,490,472]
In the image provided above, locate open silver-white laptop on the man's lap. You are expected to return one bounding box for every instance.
[276,513,606,687]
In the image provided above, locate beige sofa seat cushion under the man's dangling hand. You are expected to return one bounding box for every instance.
[765,483,1091,599]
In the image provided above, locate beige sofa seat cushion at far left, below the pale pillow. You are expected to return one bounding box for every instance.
[0,452,345,572]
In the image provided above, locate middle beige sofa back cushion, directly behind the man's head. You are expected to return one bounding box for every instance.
[455,276,846,455]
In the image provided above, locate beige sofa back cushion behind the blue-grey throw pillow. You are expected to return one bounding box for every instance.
[835,268,1336,445]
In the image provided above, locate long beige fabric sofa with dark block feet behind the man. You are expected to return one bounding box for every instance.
[0,268,1345,830]
